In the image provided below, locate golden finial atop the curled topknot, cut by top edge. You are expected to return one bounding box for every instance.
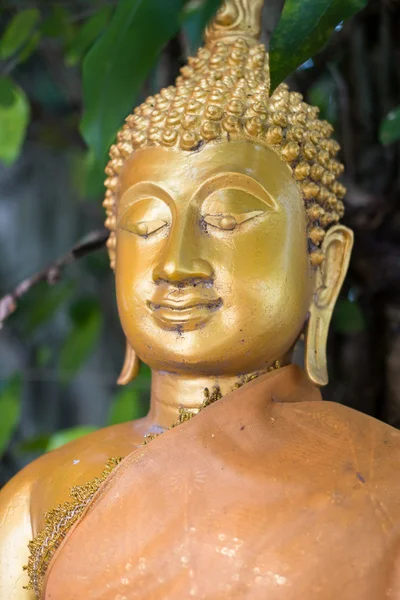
[205,0,264,46]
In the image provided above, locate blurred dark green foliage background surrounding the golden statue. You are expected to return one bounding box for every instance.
[0,0,400,485]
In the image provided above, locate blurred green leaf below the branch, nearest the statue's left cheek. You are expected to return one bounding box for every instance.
[60,299,102,383]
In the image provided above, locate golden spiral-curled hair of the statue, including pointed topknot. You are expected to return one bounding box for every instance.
[103,0,346,268]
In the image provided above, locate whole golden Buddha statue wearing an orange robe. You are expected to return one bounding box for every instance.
[0,0,400,600]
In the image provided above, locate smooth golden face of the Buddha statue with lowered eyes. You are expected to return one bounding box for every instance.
[116,140,313,375]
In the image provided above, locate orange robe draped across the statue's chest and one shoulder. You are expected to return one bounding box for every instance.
[43,366,400,600]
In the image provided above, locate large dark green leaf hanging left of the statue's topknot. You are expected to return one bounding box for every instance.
[80,0,188,162]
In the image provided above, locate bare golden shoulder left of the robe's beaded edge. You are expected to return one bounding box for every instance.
[0,421,143,600]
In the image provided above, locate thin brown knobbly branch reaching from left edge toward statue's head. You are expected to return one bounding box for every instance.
[0,229,109,328]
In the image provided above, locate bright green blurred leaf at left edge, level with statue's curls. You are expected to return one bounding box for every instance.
[0,77,30,165]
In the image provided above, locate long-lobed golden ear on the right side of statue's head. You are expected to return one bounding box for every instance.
[305,225,354,386]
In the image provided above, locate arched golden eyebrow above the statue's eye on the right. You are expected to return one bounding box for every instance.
[193,171,278,210]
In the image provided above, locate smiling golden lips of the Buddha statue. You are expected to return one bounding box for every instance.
[147,298,222,331]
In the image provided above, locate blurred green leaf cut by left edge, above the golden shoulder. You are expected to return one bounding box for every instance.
[0,374,22,455]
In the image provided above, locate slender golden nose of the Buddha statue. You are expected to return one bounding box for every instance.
[153,215,214,283]
